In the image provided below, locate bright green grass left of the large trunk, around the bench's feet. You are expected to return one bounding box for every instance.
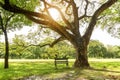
[0,61,69,80]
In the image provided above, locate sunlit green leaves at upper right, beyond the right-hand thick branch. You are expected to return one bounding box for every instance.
[99,1,120,28]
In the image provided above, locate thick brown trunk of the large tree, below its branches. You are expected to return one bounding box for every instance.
[74,39,90,68]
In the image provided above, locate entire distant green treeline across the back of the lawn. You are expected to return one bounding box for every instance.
[0,35,120,59]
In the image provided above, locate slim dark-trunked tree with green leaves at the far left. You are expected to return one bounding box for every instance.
[0,0,37,68]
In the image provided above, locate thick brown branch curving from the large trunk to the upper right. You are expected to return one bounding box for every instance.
[83,0,117,44]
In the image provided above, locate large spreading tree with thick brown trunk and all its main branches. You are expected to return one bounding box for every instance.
[1,0,118,68]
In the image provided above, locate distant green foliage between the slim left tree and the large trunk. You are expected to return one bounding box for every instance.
[7,35,75,59]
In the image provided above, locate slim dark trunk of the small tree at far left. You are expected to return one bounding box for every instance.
[4,30,9,69]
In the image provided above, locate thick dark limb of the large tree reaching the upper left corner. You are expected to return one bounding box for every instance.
[1,0,71,39]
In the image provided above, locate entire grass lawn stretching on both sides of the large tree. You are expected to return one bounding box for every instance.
[0,60,120,80]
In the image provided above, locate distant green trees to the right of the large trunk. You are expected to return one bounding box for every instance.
[88,40,120,58]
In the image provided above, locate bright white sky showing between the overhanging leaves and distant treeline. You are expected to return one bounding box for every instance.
[0,27,120,46]
